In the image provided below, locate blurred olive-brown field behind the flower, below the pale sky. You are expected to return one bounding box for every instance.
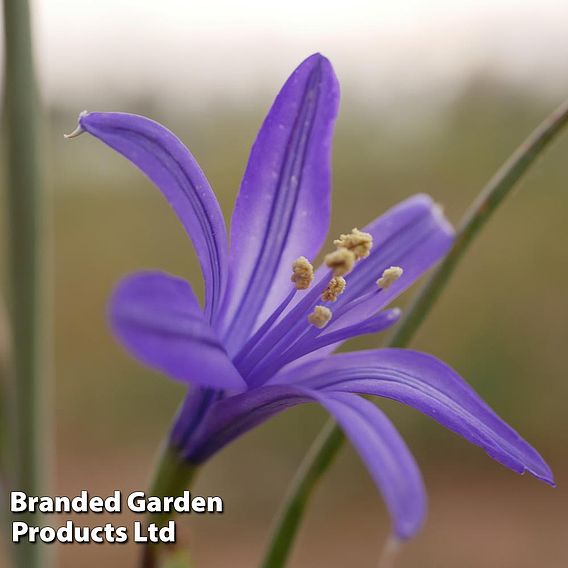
[1,78,568,568]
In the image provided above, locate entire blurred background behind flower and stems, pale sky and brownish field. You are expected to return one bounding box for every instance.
[0,0,568,568]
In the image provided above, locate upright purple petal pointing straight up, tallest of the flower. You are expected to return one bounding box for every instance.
[220,54,339,350]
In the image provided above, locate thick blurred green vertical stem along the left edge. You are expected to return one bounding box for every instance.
[4,0,49,568]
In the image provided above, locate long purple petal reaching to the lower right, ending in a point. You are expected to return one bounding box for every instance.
[276,349,554,484]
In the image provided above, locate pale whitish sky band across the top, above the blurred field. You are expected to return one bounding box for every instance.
[14,0,568,110]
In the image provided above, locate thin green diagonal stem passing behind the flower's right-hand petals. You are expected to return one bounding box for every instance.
[261,100,568,568]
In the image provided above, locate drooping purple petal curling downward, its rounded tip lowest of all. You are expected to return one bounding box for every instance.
[177,385,426,538]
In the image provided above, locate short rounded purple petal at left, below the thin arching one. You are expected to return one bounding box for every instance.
[110,272,246,390]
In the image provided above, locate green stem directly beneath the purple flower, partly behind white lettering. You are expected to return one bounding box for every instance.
[140,446,198,568]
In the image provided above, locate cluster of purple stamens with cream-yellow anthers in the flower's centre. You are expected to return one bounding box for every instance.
[234,224,402,387]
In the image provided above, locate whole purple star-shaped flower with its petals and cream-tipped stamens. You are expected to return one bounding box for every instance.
[73,54,553,538]
